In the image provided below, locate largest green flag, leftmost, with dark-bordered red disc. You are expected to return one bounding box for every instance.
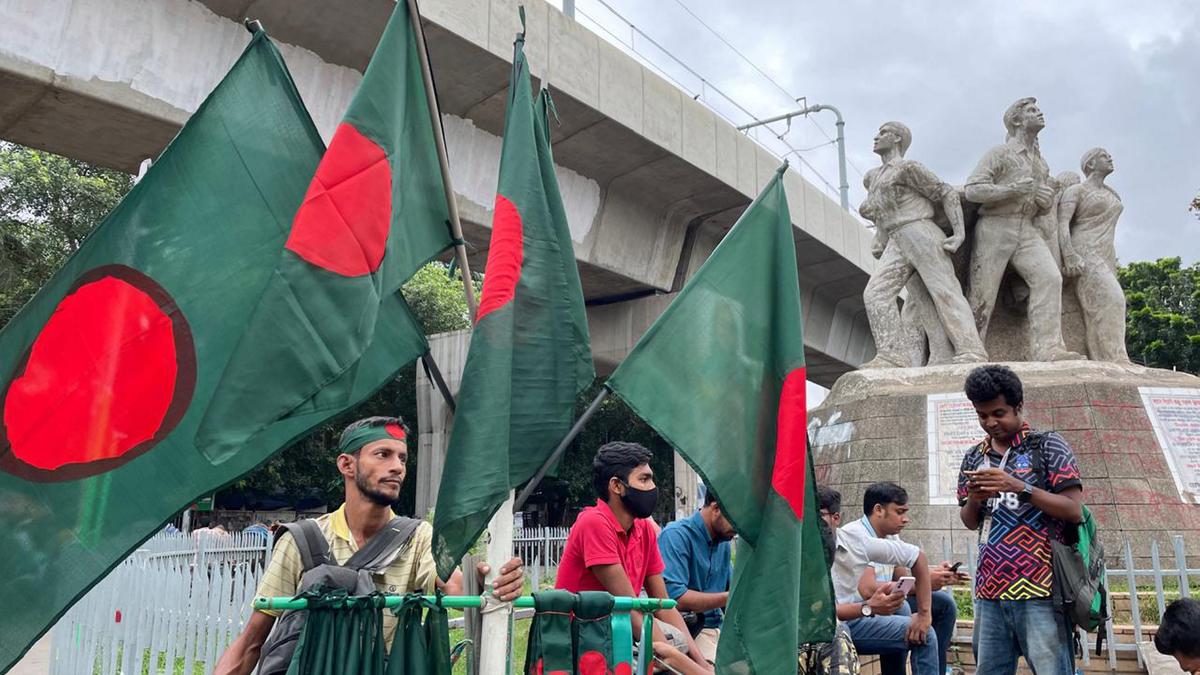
[0,32,323,671]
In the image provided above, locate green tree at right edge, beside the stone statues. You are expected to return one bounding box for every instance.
[1117,257,1200,374]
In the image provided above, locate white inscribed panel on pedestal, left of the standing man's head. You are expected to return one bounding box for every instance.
[925,392,983,504]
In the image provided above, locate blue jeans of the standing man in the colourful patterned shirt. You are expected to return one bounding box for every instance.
[972,598,1075,675]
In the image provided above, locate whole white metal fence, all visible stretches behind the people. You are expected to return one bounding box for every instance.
[50,527,1200,675]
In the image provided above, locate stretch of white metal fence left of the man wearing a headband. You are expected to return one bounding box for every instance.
[50,532,270,675]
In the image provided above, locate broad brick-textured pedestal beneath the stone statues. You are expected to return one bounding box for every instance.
[809,362,1200,562]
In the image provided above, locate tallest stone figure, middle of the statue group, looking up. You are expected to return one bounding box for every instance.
[965,97,1084,362]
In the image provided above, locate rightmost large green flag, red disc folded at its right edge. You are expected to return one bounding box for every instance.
[608,165,834,675]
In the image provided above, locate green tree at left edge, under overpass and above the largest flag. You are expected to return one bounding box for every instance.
[0,142,133,328]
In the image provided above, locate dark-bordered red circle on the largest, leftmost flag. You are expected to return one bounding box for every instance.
[0,265,196,482]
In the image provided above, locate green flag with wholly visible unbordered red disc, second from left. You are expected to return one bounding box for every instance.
[197,2,451,461]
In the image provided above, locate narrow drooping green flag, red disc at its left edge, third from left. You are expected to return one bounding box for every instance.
[433,23,595,579]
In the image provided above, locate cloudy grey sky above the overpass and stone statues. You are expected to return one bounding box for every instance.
[557,0,1200,263]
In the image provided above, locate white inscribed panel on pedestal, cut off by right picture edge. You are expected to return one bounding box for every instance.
[1139,387,1200,504]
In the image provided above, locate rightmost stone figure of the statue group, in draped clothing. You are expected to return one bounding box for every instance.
[1057,148,1129,363]
